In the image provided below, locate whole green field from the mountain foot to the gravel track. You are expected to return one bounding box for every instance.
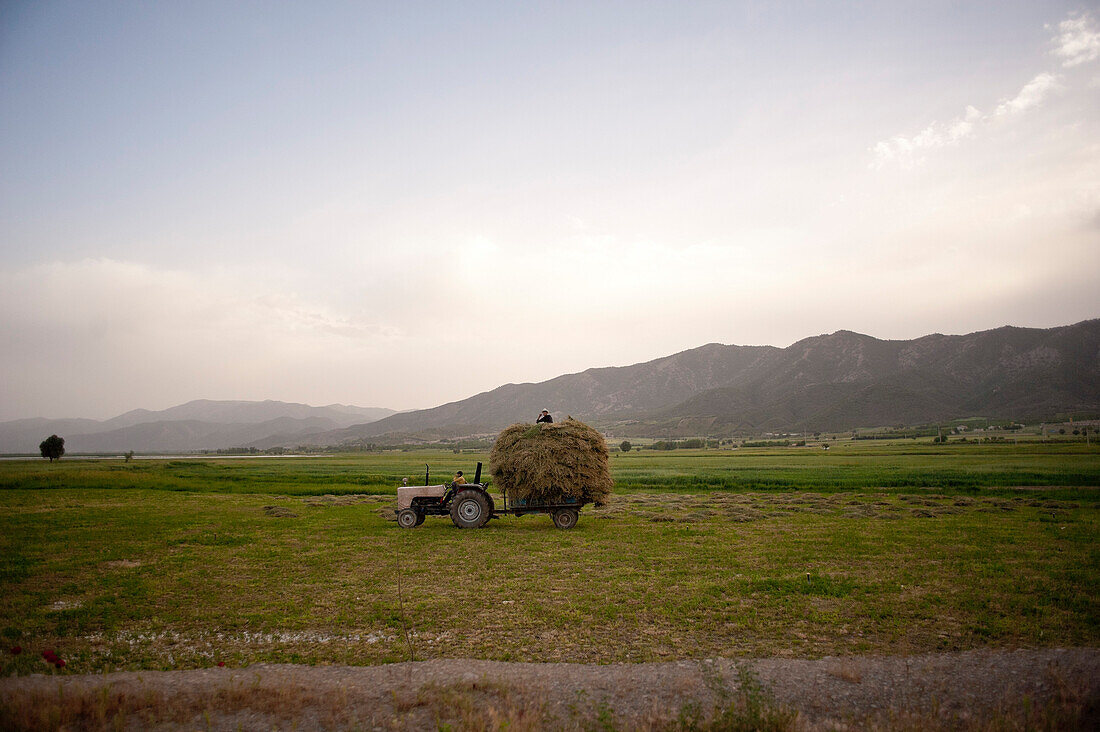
[0,444,1100,675]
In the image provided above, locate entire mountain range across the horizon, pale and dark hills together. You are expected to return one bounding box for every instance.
[0,319,1100,452]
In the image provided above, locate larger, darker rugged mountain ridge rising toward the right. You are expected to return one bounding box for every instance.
[309,320,1100,444]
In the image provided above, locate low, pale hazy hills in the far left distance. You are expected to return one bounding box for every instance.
[0,400,395,452]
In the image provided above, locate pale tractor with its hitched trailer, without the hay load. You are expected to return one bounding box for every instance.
[396,462,584,528]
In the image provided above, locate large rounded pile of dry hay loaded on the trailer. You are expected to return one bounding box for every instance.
[488,417,613,505]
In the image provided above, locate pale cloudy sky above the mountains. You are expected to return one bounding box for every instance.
[0,0,1100,419]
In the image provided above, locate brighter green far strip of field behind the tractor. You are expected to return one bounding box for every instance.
[0,441,1100,495]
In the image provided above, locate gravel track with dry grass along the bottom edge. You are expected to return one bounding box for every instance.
[0,648,1100,730]
